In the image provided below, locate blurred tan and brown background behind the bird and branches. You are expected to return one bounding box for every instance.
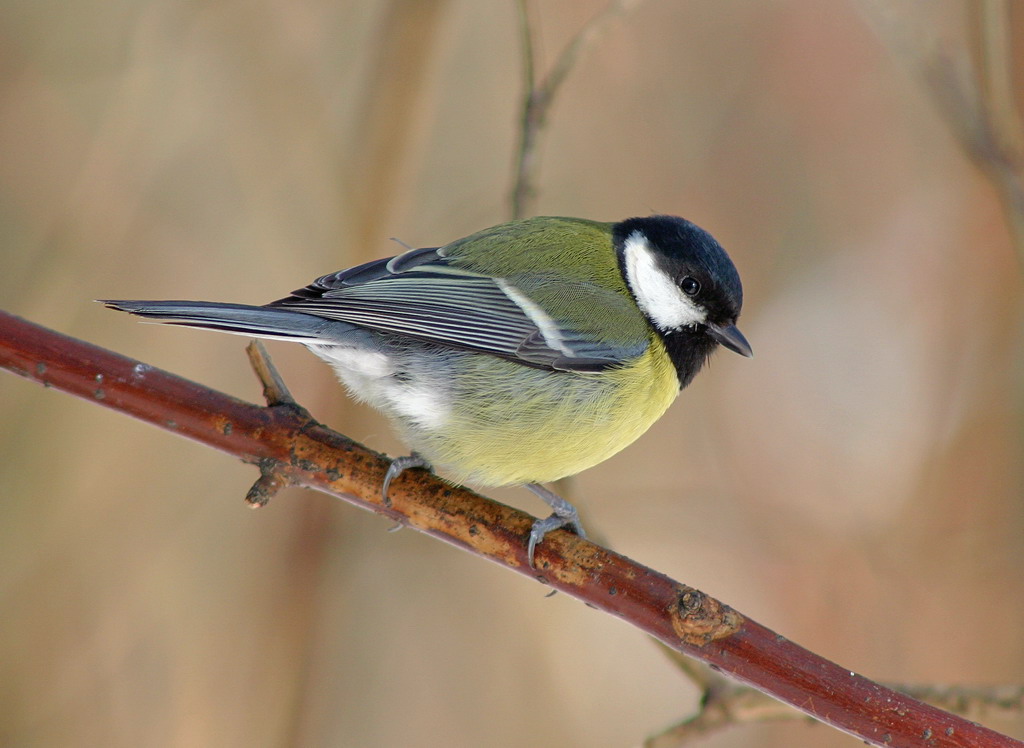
[0,0,1024,747]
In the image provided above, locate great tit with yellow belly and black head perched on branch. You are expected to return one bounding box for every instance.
[103,215,751,565]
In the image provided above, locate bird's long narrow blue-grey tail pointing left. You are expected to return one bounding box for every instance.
[100,299,339,343]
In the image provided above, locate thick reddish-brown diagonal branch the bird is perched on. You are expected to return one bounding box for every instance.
[0,305,1024,748]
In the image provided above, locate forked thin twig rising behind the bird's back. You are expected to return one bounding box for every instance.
[512,0,642,218]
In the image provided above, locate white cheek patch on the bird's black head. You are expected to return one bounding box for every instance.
[623,231,708,331]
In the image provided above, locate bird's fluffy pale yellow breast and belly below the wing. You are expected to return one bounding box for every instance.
[406,339,679,486]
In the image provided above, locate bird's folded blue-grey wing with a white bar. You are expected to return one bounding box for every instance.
[268,248,647,371]
